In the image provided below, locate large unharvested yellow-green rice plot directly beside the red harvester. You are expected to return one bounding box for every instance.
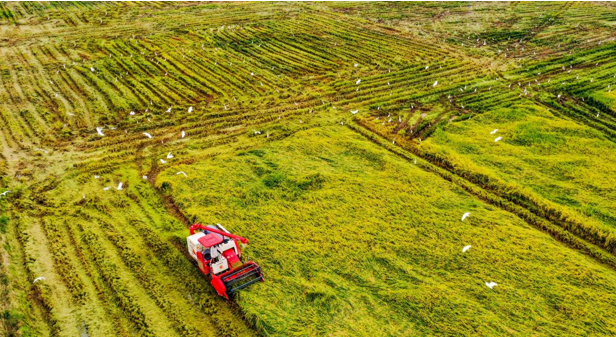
[157,126,616,335]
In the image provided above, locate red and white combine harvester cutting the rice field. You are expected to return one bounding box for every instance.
[186,223,264,299]
